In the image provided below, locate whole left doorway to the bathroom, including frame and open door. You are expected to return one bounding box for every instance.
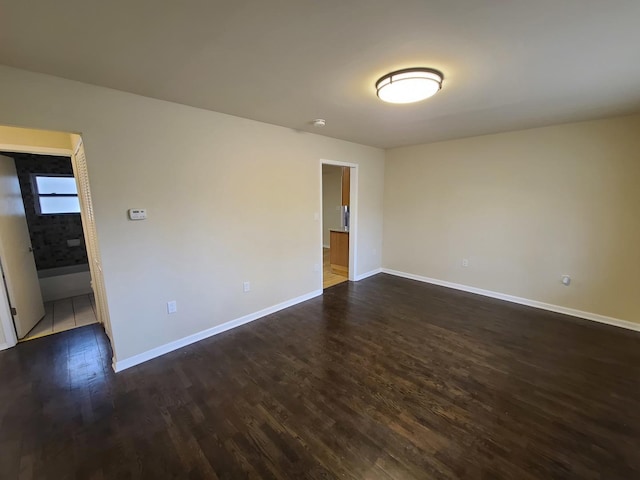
[0,126,111,349]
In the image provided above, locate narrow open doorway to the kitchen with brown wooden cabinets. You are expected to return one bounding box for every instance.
[321,160,357,289]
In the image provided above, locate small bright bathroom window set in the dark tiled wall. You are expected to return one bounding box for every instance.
[33,175,80,215]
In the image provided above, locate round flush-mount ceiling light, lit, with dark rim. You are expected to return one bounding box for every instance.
[376,67,444,103]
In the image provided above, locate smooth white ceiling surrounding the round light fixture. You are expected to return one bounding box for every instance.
[0,0,640,148]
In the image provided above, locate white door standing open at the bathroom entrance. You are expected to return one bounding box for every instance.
[0,155,44,338]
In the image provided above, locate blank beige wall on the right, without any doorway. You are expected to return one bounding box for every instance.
[383,115,640,322]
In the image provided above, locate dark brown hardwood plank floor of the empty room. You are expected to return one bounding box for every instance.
[0,274,640,480]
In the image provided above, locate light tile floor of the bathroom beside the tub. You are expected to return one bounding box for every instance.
[21,294,98,341]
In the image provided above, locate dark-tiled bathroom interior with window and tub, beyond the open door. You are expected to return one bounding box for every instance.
[0,152,97,341]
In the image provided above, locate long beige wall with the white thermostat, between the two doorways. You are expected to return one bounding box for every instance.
[0,67,384,361]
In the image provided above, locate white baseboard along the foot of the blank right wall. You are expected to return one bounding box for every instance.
[382,268,640,332]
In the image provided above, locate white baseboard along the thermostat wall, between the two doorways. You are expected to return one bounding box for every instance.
[112,289,322,372]
